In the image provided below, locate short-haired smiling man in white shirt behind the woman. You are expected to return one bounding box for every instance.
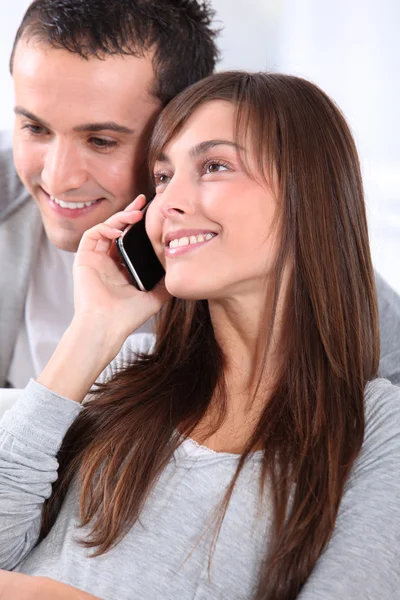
[0,0,217,387]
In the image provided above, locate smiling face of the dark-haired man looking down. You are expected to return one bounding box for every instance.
[13,39,161,252]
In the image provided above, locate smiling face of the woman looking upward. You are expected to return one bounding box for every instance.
[146,100,277,299]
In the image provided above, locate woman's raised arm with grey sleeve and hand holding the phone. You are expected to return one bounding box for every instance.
[0,201,168,570]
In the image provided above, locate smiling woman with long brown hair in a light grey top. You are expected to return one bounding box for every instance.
[0,72,400,600]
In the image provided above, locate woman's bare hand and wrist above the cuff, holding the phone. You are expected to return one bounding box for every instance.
[38,195,170,402]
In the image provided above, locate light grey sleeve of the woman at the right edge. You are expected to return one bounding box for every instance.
[298,380,400,600]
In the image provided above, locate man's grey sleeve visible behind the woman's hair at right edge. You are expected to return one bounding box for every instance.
[375,273,400,385]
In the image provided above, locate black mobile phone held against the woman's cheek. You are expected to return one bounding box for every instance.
[117,202,165,292]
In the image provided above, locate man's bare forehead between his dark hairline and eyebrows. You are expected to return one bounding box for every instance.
[13,40,161,130]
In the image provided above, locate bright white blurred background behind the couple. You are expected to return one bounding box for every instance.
[0,0,400,293]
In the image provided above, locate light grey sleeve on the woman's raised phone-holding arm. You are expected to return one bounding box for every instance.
[0,380,82,570]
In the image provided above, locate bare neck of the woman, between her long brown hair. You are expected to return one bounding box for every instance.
[191,296,279,454]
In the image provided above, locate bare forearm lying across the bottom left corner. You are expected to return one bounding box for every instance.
[0,571,100,600]
